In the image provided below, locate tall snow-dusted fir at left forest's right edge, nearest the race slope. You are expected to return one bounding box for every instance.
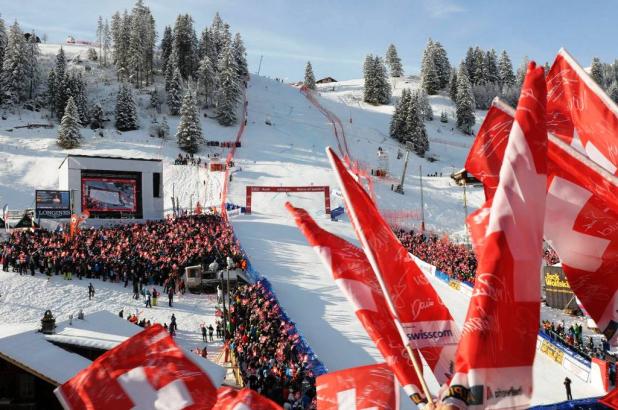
[216,43,241,126]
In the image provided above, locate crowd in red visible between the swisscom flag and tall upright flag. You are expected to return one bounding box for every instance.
[395,229,476,284]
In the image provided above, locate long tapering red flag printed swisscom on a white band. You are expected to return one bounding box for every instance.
[326,148,459,356]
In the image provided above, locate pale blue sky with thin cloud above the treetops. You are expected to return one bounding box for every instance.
[0,0,618,81]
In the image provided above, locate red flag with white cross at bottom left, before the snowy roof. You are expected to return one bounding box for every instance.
[54,324,217,410]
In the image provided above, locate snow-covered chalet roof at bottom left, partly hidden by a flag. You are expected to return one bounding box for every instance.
[0,311,225,386]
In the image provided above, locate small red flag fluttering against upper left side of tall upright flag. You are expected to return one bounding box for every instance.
[465,98,515,200]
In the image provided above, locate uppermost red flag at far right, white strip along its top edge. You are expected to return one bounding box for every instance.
[547,49,618,175]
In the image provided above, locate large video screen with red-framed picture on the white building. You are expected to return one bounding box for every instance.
[82,177,137,212]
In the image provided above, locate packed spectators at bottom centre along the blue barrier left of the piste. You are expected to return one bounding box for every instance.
[229,281,316,409]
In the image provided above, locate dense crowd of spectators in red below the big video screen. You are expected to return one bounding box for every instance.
[0,215,243,287]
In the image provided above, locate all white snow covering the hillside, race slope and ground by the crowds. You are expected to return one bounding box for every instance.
[0,45,600,406]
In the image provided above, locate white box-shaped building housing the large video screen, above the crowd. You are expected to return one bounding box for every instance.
[59,155,163,221]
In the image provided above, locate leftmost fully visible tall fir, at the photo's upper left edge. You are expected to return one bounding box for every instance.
[0,21,28,104]
